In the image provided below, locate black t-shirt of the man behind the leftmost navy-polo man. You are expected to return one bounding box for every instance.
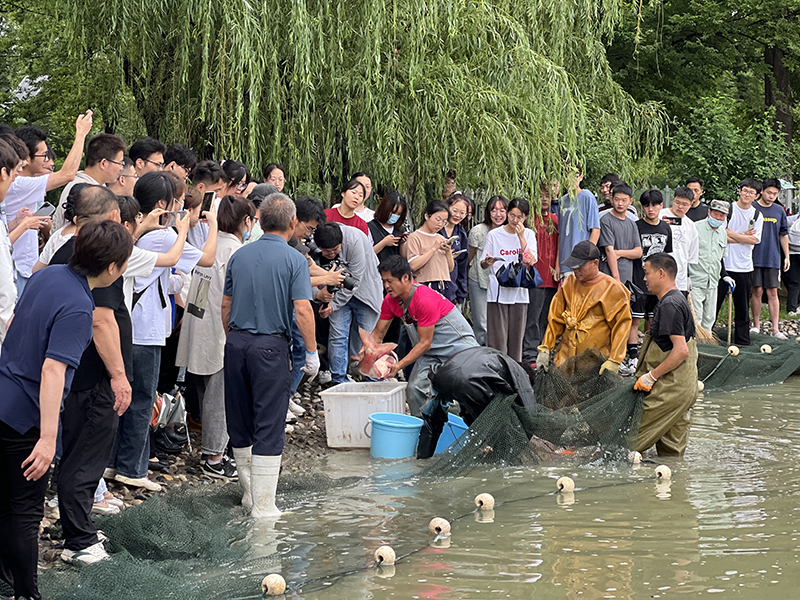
[50,236,133,392]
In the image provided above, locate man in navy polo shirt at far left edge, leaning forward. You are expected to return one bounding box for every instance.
[0,221,133,599]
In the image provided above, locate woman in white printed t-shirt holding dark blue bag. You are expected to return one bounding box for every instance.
[481,198,537,362]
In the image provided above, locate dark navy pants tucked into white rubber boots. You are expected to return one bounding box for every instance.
[225,331,292,456]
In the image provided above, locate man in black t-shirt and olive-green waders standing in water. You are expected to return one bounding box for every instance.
[633,252,697,456]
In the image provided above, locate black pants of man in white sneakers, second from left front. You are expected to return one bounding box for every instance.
[58,374,119,550]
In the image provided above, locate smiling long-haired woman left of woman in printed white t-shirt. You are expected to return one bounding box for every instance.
[467,196,508,346]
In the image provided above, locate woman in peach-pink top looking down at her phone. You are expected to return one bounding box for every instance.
[401,200,455,294]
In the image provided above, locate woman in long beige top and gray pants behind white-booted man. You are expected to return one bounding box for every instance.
[175,196,256,478]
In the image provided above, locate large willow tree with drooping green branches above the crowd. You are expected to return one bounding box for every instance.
[56,0,665,203]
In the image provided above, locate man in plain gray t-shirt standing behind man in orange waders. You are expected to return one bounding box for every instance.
[597,184,642,283]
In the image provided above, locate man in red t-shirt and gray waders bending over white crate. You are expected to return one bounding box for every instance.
[372,256,478,417]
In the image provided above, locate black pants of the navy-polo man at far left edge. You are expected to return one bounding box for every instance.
[0,421,47,600]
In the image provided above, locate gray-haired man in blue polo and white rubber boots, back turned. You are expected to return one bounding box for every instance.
[222,194,319,518]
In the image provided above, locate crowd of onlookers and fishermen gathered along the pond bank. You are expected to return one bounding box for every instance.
[0,111,800,598]
